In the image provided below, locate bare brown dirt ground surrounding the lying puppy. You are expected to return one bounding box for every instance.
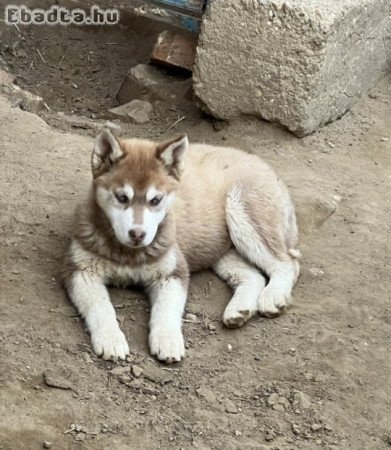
[0,6,391,450]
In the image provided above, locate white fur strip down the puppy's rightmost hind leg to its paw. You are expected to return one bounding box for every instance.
[226,187,298,315]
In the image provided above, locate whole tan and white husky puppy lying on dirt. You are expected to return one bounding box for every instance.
[64,130,299,363]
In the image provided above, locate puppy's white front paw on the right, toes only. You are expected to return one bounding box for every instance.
[149,327,185,364]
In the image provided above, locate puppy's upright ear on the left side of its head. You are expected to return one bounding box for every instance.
[91,128,123,178]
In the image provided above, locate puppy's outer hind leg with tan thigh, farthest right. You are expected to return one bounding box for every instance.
[226,187,299,316]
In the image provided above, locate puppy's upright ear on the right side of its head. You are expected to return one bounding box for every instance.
[156,134,189,180]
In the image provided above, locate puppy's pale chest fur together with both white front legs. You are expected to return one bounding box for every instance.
[69,241,182,361]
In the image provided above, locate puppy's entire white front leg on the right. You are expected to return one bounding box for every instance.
[148,277,187,362]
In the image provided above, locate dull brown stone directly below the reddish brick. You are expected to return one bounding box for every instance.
[117,64,192,105]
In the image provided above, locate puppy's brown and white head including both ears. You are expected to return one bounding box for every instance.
[91,130,188,248]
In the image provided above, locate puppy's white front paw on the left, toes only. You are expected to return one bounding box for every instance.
[91,326,129,361]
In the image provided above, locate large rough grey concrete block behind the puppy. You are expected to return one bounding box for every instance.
[193,0,391,136]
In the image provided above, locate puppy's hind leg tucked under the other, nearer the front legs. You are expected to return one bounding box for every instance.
[213,249,266,328]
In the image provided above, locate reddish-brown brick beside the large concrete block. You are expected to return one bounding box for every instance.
[151,30,197,71]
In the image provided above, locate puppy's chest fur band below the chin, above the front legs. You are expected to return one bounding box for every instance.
[72,241,176,287]
